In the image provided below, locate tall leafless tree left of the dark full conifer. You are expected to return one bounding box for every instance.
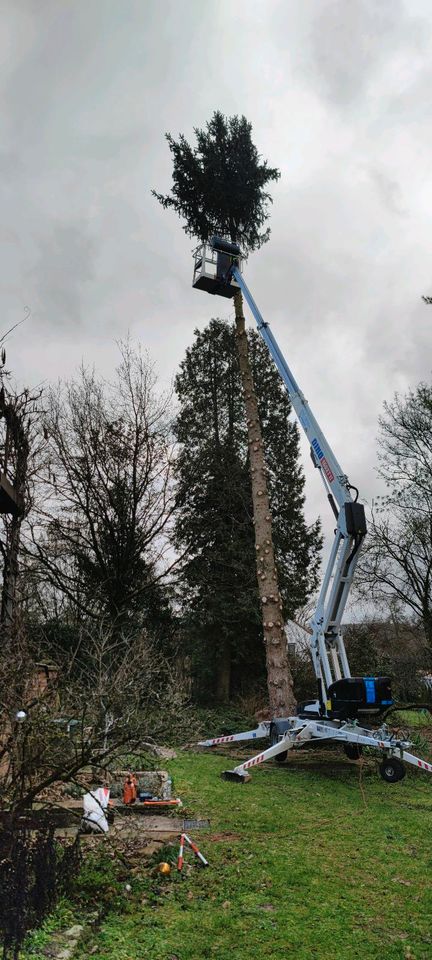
[28,342,174,626]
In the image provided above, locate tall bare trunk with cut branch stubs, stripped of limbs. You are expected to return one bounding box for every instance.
[234,291,296,717]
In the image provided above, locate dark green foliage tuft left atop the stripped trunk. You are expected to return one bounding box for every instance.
[152,111,280,253]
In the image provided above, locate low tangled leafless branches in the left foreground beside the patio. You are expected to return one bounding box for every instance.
[0,623,191,823]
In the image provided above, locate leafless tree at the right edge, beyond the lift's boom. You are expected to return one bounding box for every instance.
[359,383,432,654]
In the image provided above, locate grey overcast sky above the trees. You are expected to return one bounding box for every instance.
[0,0,432,540]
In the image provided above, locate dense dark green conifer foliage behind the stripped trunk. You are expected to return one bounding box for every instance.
[176,320,321,698]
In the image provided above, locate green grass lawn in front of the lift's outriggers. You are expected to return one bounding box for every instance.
[23,752,432,960]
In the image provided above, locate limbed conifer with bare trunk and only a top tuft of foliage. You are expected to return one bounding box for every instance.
[153,111,304,716]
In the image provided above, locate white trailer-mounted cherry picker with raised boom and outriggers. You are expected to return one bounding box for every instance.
[193,236,432,783]
